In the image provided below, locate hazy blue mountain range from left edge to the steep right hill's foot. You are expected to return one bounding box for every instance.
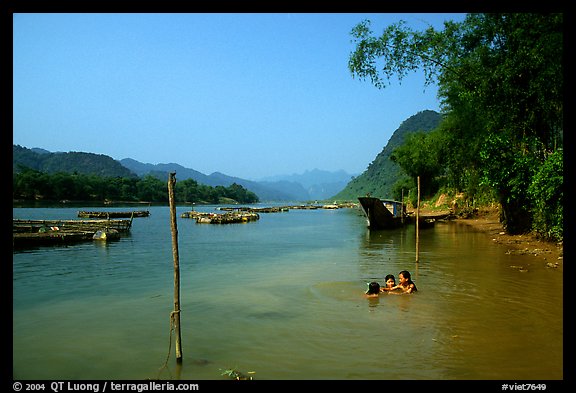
[12,145,352,202]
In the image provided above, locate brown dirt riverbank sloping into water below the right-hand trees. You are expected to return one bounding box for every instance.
[446,207,564,270]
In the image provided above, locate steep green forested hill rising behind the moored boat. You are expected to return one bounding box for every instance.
[332,110,442,200]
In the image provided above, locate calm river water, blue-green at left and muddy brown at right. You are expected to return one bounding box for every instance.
[12,206,564,380]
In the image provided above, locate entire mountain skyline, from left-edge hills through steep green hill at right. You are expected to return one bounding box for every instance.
[12,110,442,202]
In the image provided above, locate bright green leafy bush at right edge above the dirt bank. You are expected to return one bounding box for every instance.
[528,150,564,240]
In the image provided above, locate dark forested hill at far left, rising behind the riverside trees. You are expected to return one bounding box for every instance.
[12,145,136,177]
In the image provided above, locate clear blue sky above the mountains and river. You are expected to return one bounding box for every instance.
[13,13,465,180]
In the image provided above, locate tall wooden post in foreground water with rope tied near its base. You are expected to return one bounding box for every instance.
[168,172,182,363]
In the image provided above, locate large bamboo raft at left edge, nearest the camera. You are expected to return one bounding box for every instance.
[12,219,132,248]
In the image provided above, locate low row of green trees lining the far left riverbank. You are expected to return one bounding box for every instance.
[12,167,258,203]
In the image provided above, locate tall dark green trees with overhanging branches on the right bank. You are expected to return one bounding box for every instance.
[349,13,564,239]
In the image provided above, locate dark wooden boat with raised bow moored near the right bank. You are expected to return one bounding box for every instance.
[358,196,406,230]
